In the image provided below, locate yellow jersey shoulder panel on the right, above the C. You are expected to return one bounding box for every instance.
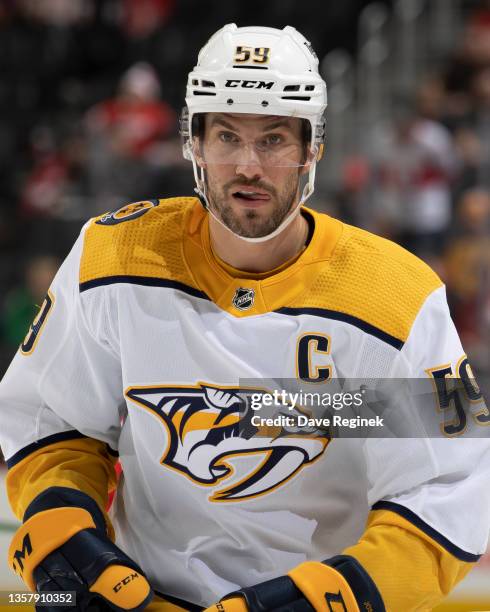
[298,217,442,346]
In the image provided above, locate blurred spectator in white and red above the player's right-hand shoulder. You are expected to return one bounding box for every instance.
[373,112,455,258]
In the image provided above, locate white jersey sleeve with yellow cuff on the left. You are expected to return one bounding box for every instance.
[0,226,124,519]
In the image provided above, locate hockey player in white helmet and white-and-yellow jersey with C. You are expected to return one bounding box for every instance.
[0,24,490,612]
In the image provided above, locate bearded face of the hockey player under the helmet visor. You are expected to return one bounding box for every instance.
[196,113,307,238]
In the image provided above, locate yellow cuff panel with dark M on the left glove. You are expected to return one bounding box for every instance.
[8,508,95,591]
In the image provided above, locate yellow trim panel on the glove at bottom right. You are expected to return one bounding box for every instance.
[288,561,360,612]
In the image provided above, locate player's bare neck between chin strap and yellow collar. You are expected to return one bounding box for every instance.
[209,208,308,273]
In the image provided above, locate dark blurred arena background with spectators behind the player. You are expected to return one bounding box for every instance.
[0,0,490,610]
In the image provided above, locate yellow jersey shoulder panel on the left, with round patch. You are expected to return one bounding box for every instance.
[80,197,196,288]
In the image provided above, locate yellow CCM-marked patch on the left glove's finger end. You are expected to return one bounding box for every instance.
[89,565,150,610]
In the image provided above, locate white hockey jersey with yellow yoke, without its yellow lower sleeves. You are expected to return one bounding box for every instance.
[0,198,490,606]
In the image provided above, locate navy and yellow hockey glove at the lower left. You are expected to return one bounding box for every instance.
[9,487,153,612]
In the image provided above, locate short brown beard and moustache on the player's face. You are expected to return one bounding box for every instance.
[206,173,299,238]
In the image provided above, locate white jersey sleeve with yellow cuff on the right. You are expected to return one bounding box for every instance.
[344,287,490,610]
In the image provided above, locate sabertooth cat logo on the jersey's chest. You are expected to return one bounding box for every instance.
[126,383,330,502]
